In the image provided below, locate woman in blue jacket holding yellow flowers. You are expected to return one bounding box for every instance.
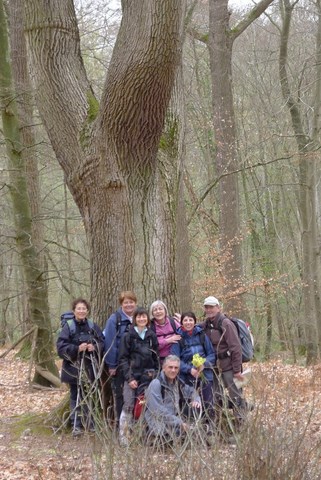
[171,312,216,418]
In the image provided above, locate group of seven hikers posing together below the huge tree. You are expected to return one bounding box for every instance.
[57,291,246,445]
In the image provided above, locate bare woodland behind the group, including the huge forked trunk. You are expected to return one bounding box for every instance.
[0,0,321,385]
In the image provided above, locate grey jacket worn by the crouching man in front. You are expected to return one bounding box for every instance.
[145,372,201,435]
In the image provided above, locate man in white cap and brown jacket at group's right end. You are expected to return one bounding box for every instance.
[203,296,246,428]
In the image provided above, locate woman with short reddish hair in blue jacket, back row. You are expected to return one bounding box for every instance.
[104,290,137,422]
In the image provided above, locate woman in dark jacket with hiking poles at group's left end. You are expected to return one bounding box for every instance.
[57,298,104,436]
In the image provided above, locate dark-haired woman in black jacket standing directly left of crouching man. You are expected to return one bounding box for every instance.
[119,307,159,445]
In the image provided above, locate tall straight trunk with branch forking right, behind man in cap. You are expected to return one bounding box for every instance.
[208,0,272,315]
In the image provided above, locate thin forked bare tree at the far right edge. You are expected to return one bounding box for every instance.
[279,0,321,364]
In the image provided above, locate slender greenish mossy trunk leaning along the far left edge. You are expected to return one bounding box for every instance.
[0,0,58,386]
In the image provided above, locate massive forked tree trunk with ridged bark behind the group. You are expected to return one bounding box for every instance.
[26,0,184,323]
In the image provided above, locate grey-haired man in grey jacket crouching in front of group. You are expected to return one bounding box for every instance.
[145,355,201,440]
